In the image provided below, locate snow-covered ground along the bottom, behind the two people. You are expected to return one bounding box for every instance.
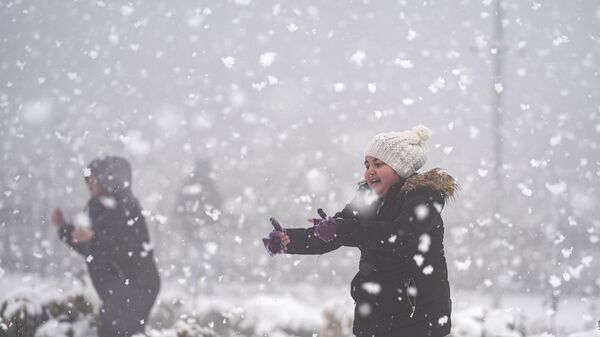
[0,275,600,337]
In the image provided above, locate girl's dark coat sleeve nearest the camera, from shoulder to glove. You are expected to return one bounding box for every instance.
[334,188,443,255]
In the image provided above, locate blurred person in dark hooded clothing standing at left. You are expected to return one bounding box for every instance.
[52,156,160,337]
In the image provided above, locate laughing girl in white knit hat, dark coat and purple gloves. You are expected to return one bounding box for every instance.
[263,126,457,337]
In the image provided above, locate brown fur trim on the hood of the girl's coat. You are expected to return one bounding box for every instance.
[401,168,460,201]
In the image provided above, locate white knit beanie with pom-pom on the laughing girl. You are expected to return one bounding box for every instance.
[365,125,431,178]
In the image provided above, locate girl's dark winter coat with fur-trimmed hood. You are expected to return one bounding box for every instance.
[286,169,457,337]
